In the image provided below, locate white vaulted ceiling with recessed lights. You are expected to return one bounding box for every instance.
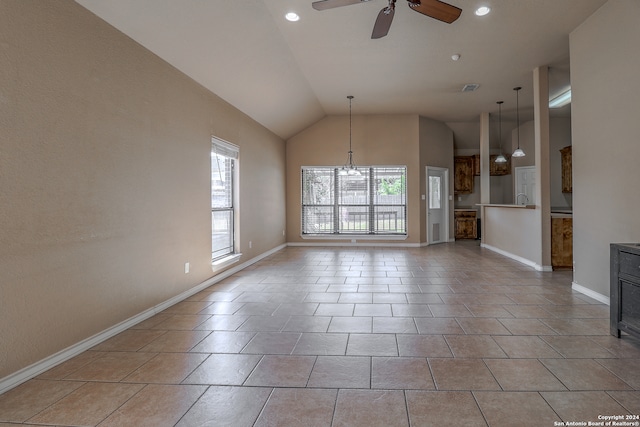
[76,0,606,139]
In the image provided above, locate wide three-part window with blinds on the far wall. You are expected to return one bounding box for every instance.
[302,166,407,235]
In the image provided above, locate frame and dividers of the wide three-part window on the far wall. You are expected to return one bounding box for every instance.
[300,165,408,241]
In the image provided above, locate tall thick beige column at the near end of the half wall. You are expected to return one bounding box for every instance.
[533,66,551,269]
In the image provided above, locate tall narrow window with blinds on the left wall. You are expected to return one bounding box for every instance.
[211,138,238,261]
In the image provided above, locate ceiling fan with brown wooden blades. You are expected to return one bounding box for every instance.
[311,0,462,39]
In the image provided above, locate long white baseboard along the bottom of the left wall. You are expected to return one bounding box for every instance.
[0,244,287,394]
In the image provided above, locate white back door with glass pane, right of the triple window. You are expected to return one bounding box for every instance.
[426,166,449,245]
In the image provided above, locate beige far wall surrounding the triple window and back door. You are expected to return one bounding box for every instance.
[287,115,453,244]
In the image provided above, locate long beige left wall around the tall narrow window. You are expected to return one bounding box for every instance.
[0,0,285,378]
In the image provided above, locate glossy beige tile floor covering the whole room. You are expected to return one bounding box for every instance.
[0,242,640,427]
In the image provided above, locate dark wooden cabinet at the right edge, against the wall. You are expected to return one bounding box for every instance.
[610,243,640,338]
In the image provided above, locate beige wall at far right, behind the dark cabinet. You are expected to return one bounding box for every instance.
[570,0,640,296]
